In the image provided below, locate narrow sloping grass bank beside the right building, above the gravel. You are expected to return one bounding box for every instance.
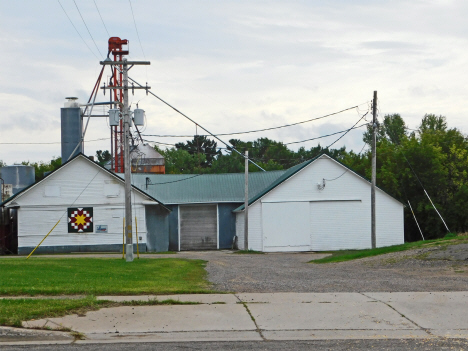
[310,235,468,263]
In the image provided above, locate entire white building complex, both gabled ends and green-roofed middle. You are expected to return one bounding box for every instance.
[0,154,404,254]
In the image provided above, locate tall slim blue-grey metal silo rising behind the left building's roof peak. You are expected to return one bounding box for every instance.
[60,97,83,164]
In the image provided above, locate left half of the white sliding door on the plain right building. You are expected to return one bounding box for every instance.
[262,202,310,251]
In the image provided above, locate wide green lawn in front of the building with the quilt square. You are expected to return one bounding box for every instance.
[0,257,211,296]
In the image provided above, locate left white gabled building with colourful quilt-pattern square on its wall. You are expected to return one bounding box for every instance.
[2,154,169,254]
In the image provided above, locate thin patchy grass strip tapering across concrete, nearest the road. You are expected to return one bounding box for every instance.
[0,296,198,327]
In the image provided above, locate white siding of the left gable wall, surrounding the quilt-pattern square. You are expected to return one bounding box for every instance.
[15,157,152,247]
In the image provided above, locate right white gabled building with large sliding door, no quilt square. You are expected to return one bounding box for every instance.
[235,155,404,252]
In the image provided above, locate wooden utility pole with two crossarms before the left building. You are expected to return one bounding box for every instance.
[100,58,150,262]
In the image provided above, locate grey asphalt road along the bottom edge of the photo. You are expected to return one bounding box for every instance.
[2,339,468,351]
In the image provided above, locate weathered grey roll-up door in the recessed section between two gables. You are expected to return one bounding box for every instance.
[179,205,218,250]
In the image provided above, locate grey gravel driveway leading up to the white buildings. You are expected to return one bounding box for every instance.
[165,244,468,292]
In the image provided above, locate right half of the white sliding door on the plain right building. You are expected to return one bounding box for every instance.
[310,201,371,251]
